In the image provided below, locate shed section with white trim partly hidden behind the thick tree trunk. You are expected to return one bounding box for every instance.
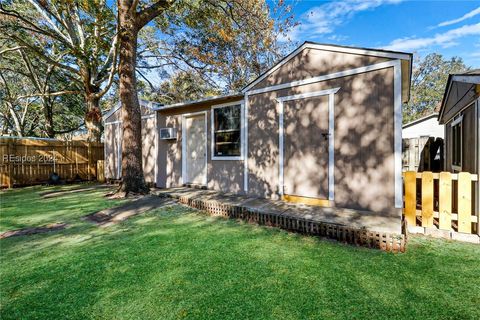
[103,100,161,185]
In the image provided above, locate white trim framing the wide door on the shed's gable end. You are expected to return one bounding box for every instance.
[276,87,340,201]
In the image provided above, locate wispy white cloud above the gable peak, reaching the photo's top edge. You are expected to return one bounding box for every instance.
[287,0,403,40]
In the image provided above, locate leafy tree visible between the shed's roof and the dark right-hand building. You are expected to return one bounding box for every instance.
[403,53,468,123]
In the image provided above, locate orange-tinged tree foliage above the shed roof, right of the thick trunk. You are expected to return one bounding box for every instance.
[137,0,296,93]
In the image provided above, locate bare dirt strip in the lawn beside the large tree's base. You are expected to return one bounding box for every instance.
[85,195,176,226]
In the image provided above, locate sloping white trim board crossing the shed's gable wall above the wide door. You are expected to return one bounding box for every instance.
[248,60,400,95]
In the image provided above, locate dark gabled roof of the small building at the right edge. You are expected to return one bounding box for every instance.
[438,69,480,123]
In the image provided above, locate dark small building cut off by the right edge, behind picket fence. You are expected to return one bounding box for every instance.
[438,69,480,174]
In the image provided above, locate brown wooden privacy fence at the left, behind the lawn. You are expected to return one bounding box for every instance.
[0,137,104,188]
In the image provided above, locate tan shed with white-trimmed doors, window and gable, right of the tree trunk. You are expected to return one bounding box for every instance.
[105,42,412,233]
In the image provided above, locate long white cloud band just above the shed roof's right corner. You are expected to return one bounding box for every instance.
[384,23,480,51]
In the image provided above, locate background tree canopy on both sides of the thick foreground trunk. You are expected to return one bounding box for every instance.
[0,0,294,140]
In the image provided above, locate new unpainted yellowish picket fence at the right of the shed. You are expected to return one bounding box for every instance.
[403,171,480,234]
